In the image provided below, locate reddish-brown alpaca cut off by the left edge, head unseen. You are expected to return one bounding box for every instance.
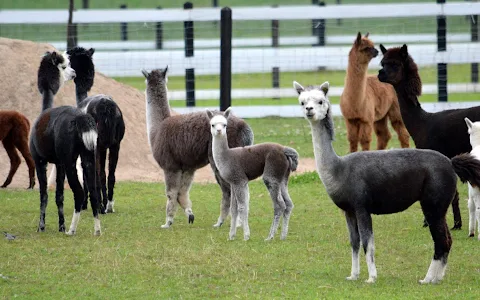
[0,110,35,189]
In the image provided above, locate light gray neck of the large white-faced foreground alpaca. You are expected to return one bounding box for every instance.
[310,116,341,183]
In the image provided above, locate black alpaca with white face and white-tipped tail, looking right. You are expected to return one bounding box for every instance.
[30,52,101,235]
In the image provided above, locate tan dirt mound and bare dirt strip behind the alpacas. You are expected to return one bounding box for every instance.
[0,38,315,188]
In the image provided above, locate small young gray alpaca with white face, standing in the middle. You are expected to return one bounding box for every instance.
[206,108,298,240]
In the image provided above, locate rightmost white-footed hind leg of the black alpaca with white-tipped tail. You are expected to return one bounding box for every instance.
[81,152,102,236]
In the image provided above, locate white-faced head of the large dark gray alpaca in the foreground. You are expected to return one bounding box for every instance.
[293,81,330,121]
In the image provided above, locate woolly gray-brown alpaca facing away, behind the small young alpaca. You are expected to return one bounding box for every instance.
[142,67,253,228]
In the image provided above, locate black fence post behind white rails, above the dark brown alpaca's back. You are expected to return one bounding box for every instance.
[437,0,448,102]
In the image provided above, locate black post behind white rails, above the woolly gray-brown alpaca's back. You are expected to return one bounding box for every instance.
[183,2,195,107]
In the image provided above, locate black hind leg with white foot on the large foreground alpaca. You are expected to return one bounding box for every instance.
[419,216,452,284]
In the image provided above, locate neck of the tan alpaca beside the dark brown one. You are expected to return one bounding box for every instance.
[345,54,368,105]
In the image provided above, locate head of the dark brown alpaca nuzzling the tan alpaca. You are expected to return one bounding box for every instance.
[378,45,408,85]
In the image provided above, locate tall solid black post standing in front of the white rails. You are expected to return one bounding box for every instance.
[220,7,232,111]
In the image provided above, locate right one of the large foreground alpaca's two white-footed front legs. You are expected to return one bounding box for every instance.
[357,211,377,283]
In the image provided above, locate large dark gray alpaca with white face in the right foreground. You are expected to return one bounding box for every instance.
[294,82,480,283]
